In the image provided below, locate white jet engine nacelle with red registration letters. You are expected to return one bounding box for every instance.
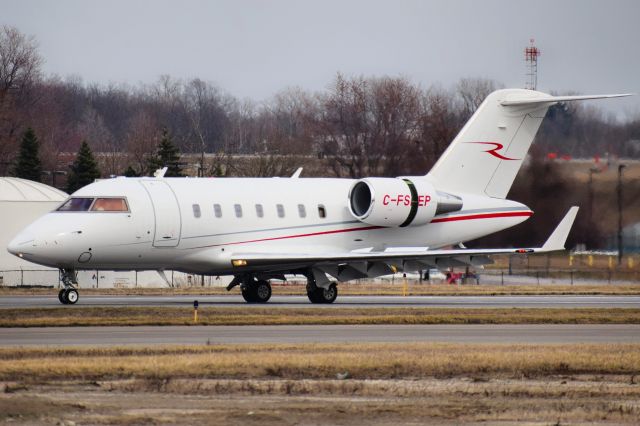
[349,177,462,227]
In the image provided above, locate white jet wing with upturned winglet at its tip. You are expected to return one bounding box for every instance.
[231,206,578,280]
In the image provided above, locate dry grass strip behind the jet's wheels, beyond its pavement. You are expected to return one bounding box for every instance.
[0,284,640,296]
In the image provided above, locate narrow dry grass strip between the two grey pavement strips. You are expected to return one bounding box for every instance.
[0,306,640,327]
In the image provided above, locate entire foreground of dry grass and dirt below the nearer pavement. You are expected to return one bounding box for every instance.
[0,343,640,426]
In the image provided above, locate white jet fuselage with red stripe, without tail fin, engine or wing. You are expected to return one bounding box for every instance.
[9,178,532,275]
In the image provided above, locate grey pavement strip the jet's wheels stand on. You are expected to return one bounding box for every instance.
[0,292,640,309]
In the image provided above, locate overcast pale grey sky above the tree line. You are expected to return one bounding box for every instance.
[0,0,640,116]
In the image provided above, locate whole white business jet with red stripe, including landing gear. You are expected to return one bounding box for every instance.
[8,89,627,304]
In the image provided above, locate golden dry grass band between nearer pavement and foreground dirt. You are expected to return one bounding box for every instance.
[0,343,640,382]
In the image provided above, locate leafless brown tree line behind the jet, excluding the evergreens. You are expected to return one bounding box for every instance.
[0,26,640,177]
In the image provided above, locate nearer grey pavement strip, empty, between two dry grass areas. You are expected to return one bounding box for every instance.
[0,324,640,347]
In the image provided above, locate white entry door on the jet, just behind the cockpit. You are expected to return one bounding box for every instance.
[140,179,182,247]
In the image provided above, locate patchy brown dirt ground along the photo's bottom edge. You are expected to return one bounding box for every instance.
[0,376,640,425]
